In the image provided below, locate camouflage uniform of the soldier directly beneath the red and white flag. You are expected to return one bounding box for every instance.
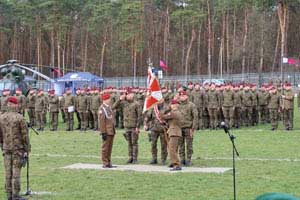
[144,104,168,164]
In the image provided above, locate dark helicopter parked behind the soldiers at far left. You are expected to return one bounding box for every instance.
[0,60,53,96]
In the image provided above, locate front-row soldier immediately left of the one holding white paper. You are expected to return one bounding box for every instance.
[49,90,59,131]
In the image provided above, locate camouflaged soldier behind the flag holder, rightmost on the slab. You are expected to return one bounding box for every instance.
[179,91,198,166]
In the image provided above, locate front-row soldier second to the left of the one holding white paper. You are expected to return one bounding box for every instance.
[34,90,47,131]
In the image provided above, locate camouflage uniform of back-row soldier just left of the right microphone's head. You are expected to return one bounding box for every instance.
[207,90,219,129]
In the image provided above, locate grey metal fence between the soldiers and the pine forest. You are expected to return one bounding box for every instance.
[104,72,300,87]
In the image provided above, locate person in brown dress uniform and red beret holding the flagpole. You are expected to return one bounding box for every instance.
[162,99,182,171]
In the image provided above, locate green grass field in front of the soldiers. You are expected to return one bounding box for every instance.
[0,110,300,200]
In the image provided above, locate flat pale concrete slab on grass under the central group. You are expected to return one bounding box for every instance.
[63,163,232,173]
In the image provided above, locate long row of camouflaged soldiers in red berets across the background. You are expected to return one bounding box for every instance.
[0,83,299,134]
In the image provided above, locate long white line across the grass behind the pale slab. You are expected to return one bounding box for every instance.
[31,154,300,162]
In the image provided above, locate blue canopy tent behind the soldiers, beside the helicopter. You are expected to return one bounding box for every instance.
[54,72,104,95]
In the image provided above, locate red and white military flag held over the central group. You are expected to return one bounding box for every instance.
[143,67,163,117]
